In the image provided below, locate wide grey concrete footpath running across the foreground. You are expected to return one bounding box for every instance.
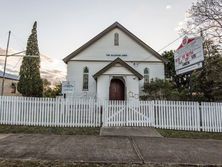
[0,134,222,165]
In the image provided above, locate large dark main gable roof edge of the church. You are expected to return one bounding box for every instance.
[63,22,167,63]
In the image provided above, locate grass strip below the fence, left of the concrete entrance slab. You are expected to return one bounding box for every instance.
[0,125,100,135]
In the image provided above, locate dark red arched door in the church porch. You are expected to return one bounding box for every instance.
[109,79,125,100]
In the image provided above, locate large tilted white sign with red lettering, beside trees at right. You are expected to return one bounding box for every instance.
[174,37,204,75]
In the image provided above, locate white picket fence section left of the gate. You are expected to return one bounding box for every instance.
[0,96,101,127]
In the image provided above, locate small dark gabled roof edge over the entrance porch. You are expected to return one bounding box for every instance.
[93,58,143,80]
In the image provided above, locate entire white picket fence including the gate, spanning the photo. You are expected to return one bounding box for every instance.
[0,96,222,132]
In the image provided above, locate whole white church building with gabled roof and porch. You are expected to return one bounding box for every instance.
[63,22,166,100]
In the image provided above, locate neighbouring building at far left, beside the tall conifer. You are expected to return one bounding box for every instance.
[0,71,20,96]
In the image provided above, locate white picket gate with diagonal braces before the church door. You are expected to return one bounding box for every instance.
[103,101,154,126]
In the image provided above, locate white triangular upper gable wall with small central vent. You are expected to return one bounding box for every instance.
[72,28,161,62]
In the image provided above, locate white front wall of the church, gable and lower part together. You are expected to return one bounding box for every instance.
[67,28,164,100]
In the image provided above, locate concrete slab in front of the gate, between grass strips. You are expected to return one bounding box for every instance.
[100,127,162,137]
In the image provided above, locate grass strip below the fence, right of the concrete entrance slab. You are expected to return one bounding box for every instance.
[156,128,222,140]
